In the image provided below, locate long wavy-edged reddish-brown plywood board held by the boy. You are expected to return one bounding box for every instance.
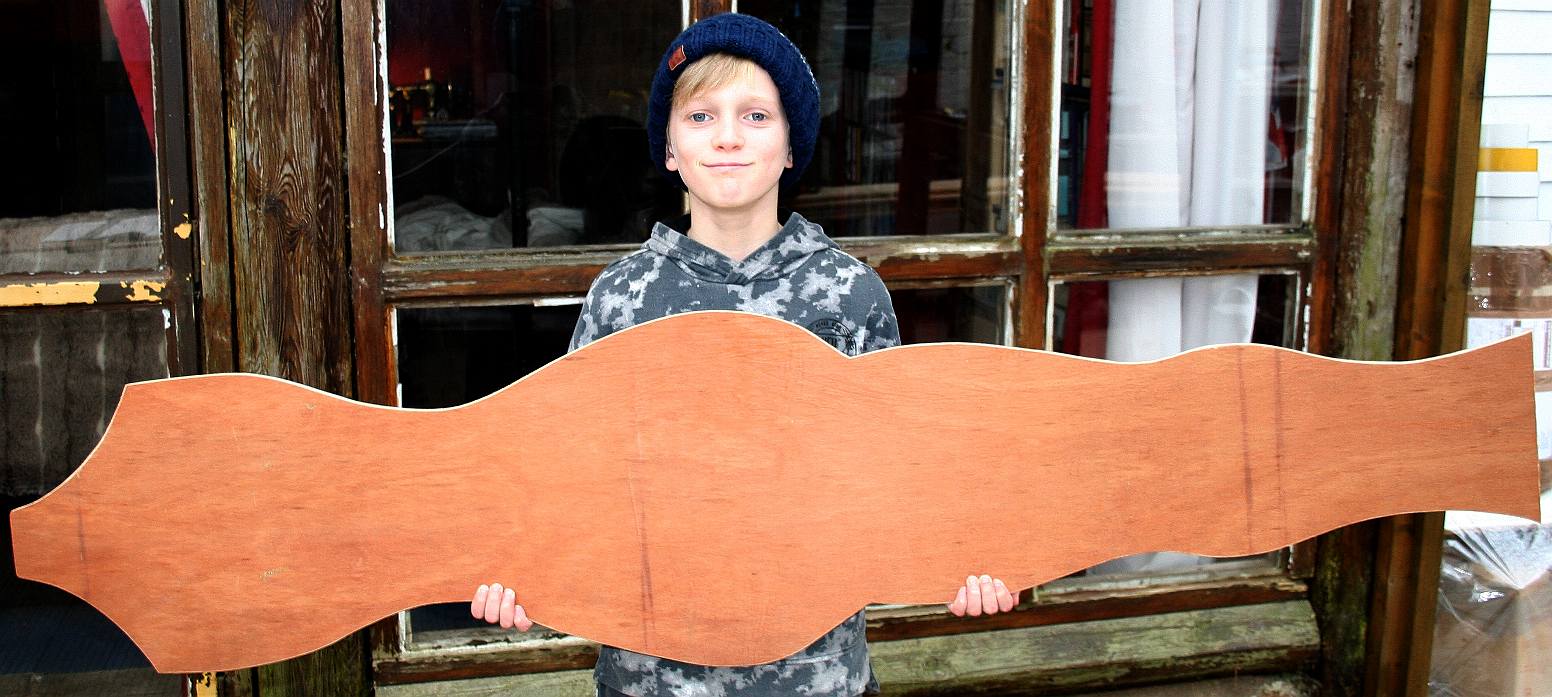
[11,312,1538,672]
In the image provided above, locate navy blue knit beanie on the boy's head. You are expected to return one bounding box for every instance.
[647,12,819,189]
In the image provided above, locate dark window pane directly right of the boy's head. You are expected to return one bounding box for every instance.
[739,0,1013,238]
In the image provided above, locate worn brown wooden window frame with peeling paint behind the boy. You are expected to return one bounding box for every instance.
[321,0,1347,685]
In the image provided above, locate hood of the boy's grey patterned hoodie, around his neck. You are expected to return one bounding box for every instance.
[646,213,840,286]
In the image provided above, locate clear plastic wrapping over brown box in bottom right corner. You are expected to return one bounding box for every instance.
[1428,522,1552,697]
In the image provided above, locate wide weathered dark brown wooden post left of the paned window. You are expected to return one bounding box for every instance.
[222,0,352,394]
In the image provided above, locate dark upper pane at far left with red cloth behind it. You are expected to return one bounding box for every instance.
[0,0,161,273]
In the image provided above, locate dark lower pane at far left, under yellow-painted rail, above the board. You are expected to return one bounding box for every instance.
[0,307,168,497]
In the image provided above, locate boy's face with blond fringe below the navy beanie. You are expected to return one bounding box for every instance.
[663,68,792,210]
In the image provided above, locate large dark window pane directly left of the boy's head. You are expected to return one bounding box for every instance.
[386,0,683,253]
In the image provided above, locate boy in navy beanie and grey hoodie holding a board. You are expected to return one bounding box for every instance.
[470,14,1015,697]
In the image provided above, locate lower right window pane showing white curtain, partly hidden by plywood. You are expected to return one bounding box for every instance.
[1051,273,1299,576]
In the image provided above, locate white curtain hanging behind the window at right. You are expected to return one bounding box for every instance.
[1096,0,1277,573]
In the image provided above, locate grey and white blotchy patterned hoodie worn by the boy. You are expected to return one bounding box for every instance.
[571,213,900,697]
